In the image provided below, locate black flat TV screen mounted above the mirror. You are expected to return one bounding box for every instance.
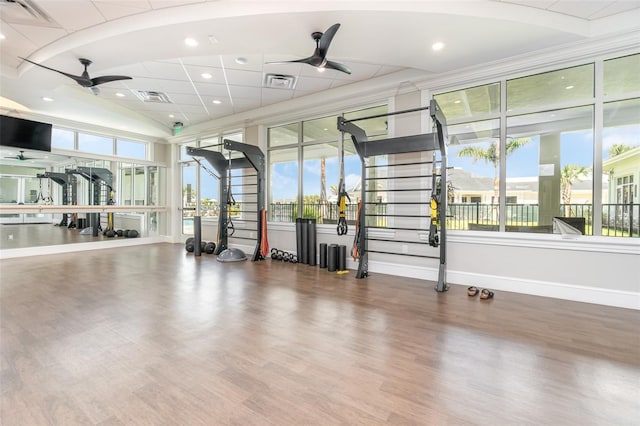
[0,115,52,152]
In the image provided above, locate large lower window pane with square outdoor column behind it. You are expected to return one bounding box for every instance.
[505,106,593,234]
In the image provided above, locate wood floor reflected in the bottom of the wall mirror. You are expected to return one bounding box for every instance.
[0,223,108,249]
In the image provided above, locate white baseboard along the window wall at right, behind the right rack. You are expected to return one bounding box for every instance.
[358,261,640,310]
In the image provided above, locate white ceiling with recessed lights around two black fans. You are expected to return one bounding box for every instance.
[0,0,640,138]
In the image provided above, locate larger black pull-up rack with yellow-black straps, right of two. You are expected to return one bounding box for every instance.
[338,100,449,291]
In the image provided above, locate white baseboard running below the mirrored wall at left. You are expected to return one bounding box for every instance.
[0,236,171,259]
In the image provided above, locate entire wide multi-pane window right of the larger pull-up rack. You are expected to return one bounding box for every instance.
[435,55,640,236]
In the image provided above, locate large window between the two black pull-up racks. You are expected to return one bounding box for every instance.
[268,105,387,224]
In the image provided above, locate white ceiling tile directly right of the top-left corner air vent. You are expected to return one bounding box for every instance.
[37,0,106,32]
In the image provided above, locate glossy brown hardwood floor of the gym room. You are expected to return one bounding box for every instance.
[0,244,640,426]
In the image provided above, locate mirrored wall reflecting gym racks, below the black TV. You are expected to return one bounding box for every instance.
[0,156,167,249]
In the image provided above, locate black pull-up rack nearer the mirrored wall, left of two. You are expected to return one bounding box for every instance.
[187,139,266,261]
